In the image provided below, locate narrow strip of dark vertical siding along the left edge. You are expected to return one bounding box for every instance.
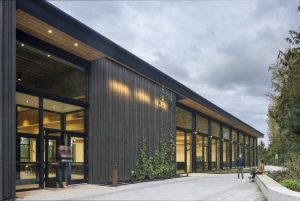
[0,0,16,200]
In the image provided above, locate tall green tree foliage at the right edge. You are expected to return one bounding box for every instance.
[268,3,300,162]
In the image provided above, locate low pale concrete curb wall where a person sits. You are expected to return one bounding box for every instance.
[255,175,300,201]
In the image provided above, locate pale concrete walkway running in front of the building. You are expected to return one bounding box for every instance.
[17,174,265,201]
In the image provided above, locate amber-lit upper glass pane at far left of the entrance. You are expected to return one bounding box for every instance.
[17,106,39,134]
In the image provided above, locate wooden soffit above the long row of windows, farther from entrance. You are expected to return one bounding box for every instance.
[177,98,262,138]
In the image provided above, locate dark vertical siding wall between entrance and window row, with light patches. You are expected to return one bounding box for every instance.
[89,58,176,184]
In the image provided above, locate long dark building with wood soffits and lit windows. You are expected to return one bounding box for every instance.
[0,0,263,199]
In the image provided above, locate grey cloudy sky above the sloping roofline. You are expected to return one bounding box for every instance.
[51,0,300,144]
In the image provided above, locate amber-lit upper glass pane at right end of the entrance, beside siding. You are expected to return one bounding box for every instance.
[66,111,84,132]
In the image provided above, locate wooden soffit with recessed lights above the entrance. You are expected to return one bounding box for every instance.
[16,9,104,61]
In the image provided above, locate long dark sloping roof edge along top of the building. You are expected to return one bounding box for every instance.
[16,0,264,137]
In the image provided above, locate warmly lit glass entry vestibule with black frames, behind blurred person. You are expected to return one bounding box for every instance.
[16,92,87,190]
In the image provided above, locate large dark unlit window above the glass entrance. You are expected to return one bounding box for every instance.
[16,42,86,100]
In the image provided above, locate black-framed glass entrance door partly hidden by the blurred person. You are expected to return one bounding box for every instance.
[44,130,65,188]
